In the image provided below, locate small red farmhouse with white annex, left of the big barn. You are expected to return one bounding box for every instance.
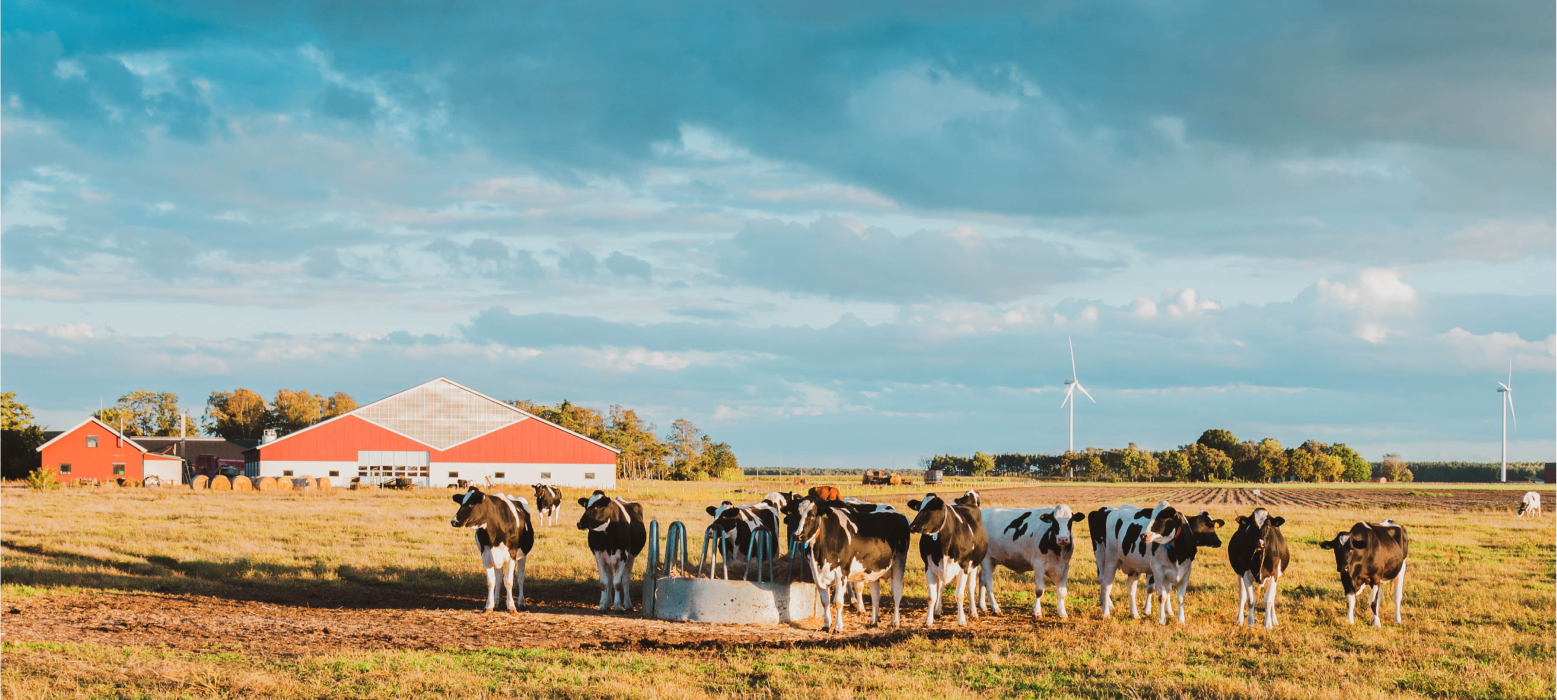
[37,418,184,482]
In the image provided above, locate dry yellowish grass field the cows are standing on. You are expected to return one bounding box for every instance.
[0,481,1557,700]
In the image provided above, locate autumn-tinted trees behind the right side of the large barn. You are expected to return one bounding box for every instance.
[509,400,741,481]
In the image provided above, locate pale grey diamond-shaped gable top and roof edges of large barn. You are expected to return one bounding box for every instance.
[254,376,621,454]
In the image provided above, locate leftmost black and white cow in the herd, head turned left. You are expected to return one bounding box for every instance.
[448,487,536,613]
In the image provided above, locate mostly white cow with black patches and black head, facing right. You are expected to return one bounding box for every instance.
[976,504,1087,618]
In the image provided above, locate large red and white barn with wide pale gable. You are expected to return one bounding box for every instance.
[243,378,618,488]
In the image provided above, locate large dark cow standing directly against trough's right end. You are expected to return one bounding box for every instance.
[796,496,909,633]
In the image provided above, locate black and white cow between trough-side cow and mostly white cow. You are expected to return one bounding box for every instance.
[908,492,989,627]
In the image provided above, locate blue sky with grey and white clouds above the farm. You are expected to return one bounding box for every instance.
[0,0,1557,467]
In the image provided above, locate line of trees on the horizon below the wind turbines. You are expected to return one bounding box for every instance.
[922,429,1382,482]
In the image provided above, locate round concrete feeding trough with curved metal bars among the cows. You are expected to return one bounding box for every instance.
[643,521,822,625]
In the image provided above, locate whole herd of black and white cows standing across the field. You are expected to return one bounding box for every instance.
[450,484,1541,632]
